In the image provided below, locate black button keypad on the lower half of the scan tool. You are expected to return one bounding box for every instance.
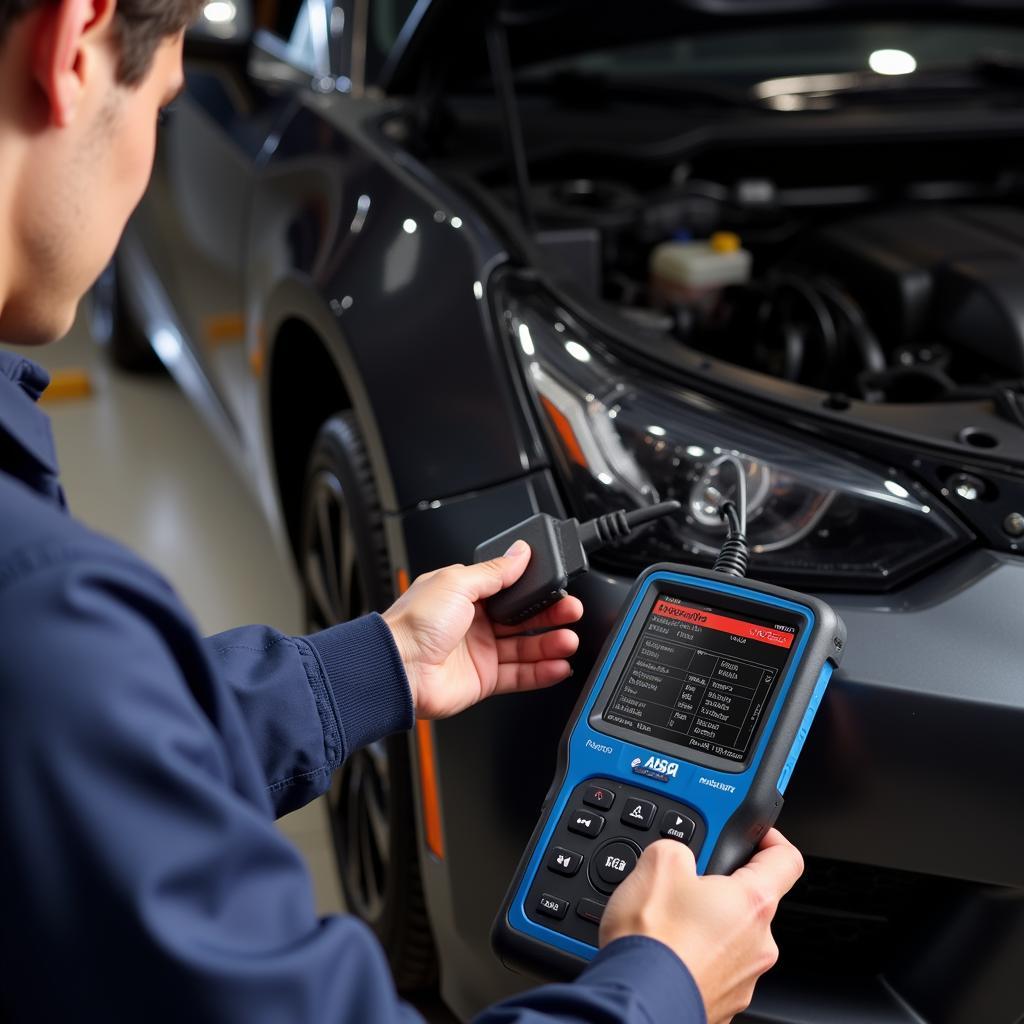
[524,778,706,946]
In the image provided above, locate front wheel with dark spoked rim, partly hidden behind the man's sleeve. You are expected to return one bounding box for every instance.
[299,413,437,992]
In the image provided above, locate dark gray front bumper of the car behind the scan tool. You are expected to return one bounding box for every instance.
[402,473,1024,1024]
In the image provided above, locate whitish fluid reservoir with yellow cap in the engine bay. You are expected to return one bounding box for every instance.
[648,231,751,306]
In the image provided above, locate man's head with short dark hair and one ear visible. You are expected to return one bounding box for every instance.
[0,0,201,344]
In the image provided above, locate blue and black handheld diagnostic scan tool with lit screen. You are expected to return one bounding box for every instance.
[493,532,846,977]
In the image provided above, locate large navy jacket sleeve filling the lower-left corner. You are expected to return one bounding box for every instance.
[0,563,420,1024]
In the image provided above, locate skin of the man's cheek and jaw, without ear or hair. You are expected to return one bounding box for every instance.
[0,17,183,344]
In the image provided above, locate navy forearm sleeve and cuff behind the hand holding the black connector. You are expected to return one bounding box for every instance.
[206,613,413,815]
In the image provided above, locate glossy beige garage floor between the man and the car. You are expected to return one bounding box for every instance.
[4,317,454,1024]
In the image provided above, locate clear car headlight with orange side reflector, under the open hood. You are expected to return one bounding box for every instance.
[501,284,971,590]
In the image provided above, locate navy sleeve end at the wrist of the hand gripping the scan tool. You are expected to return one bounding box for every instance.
[474,935,707,1024]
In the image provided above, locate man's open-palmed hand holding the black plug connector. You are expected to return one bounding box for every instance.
[384,541,583,718]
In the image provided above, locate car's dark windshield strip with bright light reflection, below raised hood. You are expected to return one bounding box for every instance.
[520,20,1024,85]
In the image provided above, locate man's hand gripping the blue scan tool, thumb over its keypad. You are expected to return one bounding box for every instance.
[600,828,804,1024]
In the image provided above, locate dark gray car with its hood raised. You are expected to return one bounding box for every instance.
[110,0,1024,1024]
